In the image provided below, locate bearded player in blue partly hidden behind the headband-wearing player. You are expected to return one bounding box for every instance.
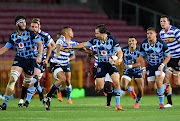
[18,19,51,108]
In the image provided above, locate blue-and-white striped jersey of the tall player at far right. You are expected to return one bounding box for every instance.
[159,26,180,58]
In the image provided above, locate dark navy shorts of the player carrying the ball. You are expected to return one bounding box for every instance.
[96,62,119,78]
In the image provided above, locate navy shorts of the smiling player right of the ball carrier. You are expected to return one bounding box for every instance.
[121,70,142,81]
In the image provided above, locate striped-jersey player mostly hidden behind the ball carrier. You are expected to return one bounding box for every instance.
[85,46,113,108]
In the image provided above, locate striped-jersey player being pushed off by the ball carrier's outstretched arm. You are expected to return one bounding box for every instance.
[43,27,78,110]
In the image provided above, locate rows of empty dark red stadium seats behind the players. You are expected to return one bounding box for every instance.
[0,6,146,60]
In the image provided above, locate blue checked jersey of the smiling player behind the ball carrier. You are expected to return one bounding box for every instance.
[121,46,141,72]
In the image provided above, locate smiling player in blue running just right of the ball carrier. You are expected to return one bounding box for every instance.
[121,36,144,108]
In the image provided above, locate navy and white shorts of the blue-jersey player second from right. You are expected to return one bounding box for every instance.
[147,64,166,81]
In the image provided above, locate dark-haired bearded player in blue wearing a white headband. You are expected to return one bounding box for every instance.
[0,15,43,110]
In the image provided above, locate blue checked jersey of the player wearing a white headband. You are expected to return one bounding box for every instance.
[6,29,40,59]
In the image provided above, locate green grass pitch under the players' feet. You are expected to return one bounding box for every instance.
[0,95,180,121]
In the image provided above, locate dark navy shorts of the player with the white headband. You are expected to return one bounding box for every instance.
[12,56,36,76]
